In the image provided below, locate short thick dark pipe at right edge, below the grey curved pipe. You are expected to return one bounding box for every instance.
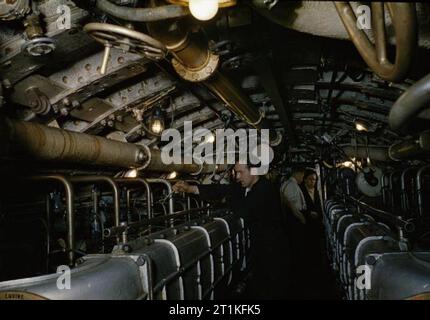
[388,130,430,161]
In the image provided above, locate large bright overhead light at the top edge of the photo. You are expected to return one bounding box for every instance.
[168,0,237,21]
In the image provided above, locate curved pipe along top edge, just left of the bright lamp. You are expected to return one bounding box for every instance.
[97,0,190,22]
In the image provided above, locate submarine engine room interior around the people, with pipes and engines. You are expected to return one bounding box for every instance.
[0,0,430,300]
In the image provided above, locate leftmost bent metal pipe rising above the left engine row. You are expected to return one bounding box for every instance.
[25,175,75,266]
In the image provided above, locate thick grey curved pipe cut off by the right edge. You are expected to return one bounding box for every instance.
[388,74,430,133]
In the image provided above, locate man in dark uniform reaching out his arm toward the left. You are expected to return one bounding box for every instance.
[173,163,290,299]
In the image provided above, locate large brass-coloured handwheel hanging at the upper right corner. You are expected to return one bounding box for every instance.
[334,2,417,82]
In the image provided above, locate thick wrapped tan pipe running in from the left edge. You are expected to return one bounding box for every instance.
[0,118,149,168]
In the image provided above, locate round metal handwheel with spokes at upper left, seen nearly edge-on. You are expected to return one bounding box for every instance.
[84,23,167,60]
